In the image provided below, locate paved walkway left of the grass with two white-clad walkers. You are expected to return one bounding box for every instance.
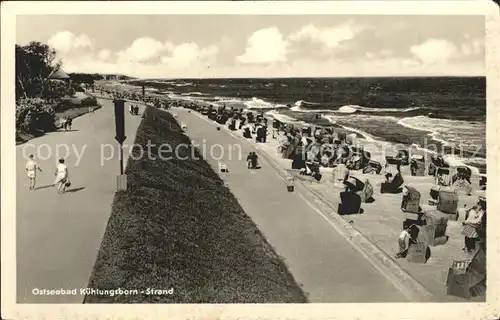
[16,100,142,303]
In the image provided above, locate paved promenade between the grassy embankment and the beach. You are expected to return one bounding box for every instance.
[173,108,407,302]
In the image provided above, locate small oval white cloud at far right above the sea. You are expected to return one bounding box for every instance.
[410,39,459,65]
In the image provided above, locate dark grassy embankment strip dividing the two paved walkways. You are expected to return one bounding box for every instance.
[85,108,307,303]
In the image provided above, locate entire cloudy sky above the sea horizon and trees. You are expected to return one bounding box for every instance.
[16,14,485,78]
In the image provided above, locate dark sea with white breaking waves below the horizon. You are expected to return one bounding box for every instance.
[129,77,486,173]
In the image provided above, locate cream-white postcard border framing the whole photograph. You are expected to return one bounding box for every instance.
[1,1,500,320]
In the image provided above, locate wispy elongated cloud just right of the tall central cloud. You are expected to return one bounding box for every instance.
[289,22,364,49]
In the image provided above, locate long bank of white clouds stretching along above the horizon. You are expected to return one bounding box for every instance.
[49,25,485,78]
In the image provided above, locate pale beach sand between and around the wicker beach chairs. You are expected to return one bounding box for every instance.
[254,117,485,302]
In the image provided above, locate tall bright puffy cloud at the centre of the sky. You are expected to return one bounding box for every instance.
[236,27,289,64]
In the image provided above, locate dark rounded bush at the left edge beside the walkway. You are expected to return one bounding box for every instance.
[16,98,55,134]
